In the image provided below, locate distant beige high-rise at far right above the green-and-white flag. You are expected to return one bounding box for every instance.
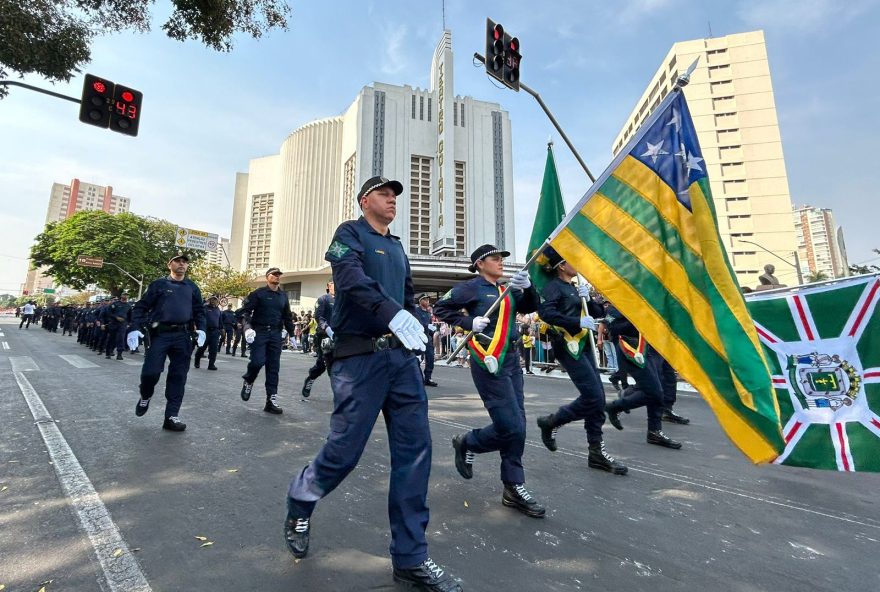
[794,205,849,280]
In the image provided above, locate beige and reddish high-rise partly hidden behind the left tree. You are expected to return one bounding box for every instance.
[21,179,131,295]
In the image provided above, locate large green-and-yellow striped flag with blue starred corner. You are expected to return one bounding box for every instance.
[550,89,785,462]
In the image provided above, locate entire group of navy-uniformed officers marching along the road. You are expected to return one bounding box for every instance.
[19,176,688,592]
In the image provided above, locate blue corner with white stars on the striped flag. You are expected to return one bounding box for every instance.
[630,93,706,210]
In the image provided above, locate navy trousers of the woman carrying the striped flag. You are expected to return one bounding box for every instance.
[465,356,526,484]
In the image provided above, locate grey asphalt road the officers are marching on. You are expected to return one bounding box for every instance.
[0,319,880,592]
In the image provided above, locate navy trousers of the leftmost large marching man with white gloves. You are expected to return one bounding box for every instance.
[140,331,192,417]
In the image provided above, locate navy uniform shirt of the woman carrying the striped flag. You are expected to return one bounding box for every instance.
[434,276,538,342]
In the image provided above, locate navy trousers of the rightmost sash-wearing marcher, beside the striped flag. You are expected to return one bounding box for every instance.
[614,342,675,431]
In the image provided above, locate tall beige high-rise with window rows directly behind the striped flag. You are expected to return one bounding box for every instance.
[613,31,798,287]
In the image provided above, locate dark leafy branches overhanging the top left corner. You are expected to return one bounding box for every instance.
[0,0,290,98]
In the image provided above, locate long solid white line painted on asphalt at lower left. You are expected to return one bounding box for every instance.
[13,365,152,592]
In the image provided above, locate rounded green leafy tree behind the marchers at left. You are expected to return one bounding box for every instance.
[31,210,199,296]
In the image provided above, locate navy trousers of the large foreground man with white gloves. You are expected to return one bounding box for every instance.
[288,349,431,569]
